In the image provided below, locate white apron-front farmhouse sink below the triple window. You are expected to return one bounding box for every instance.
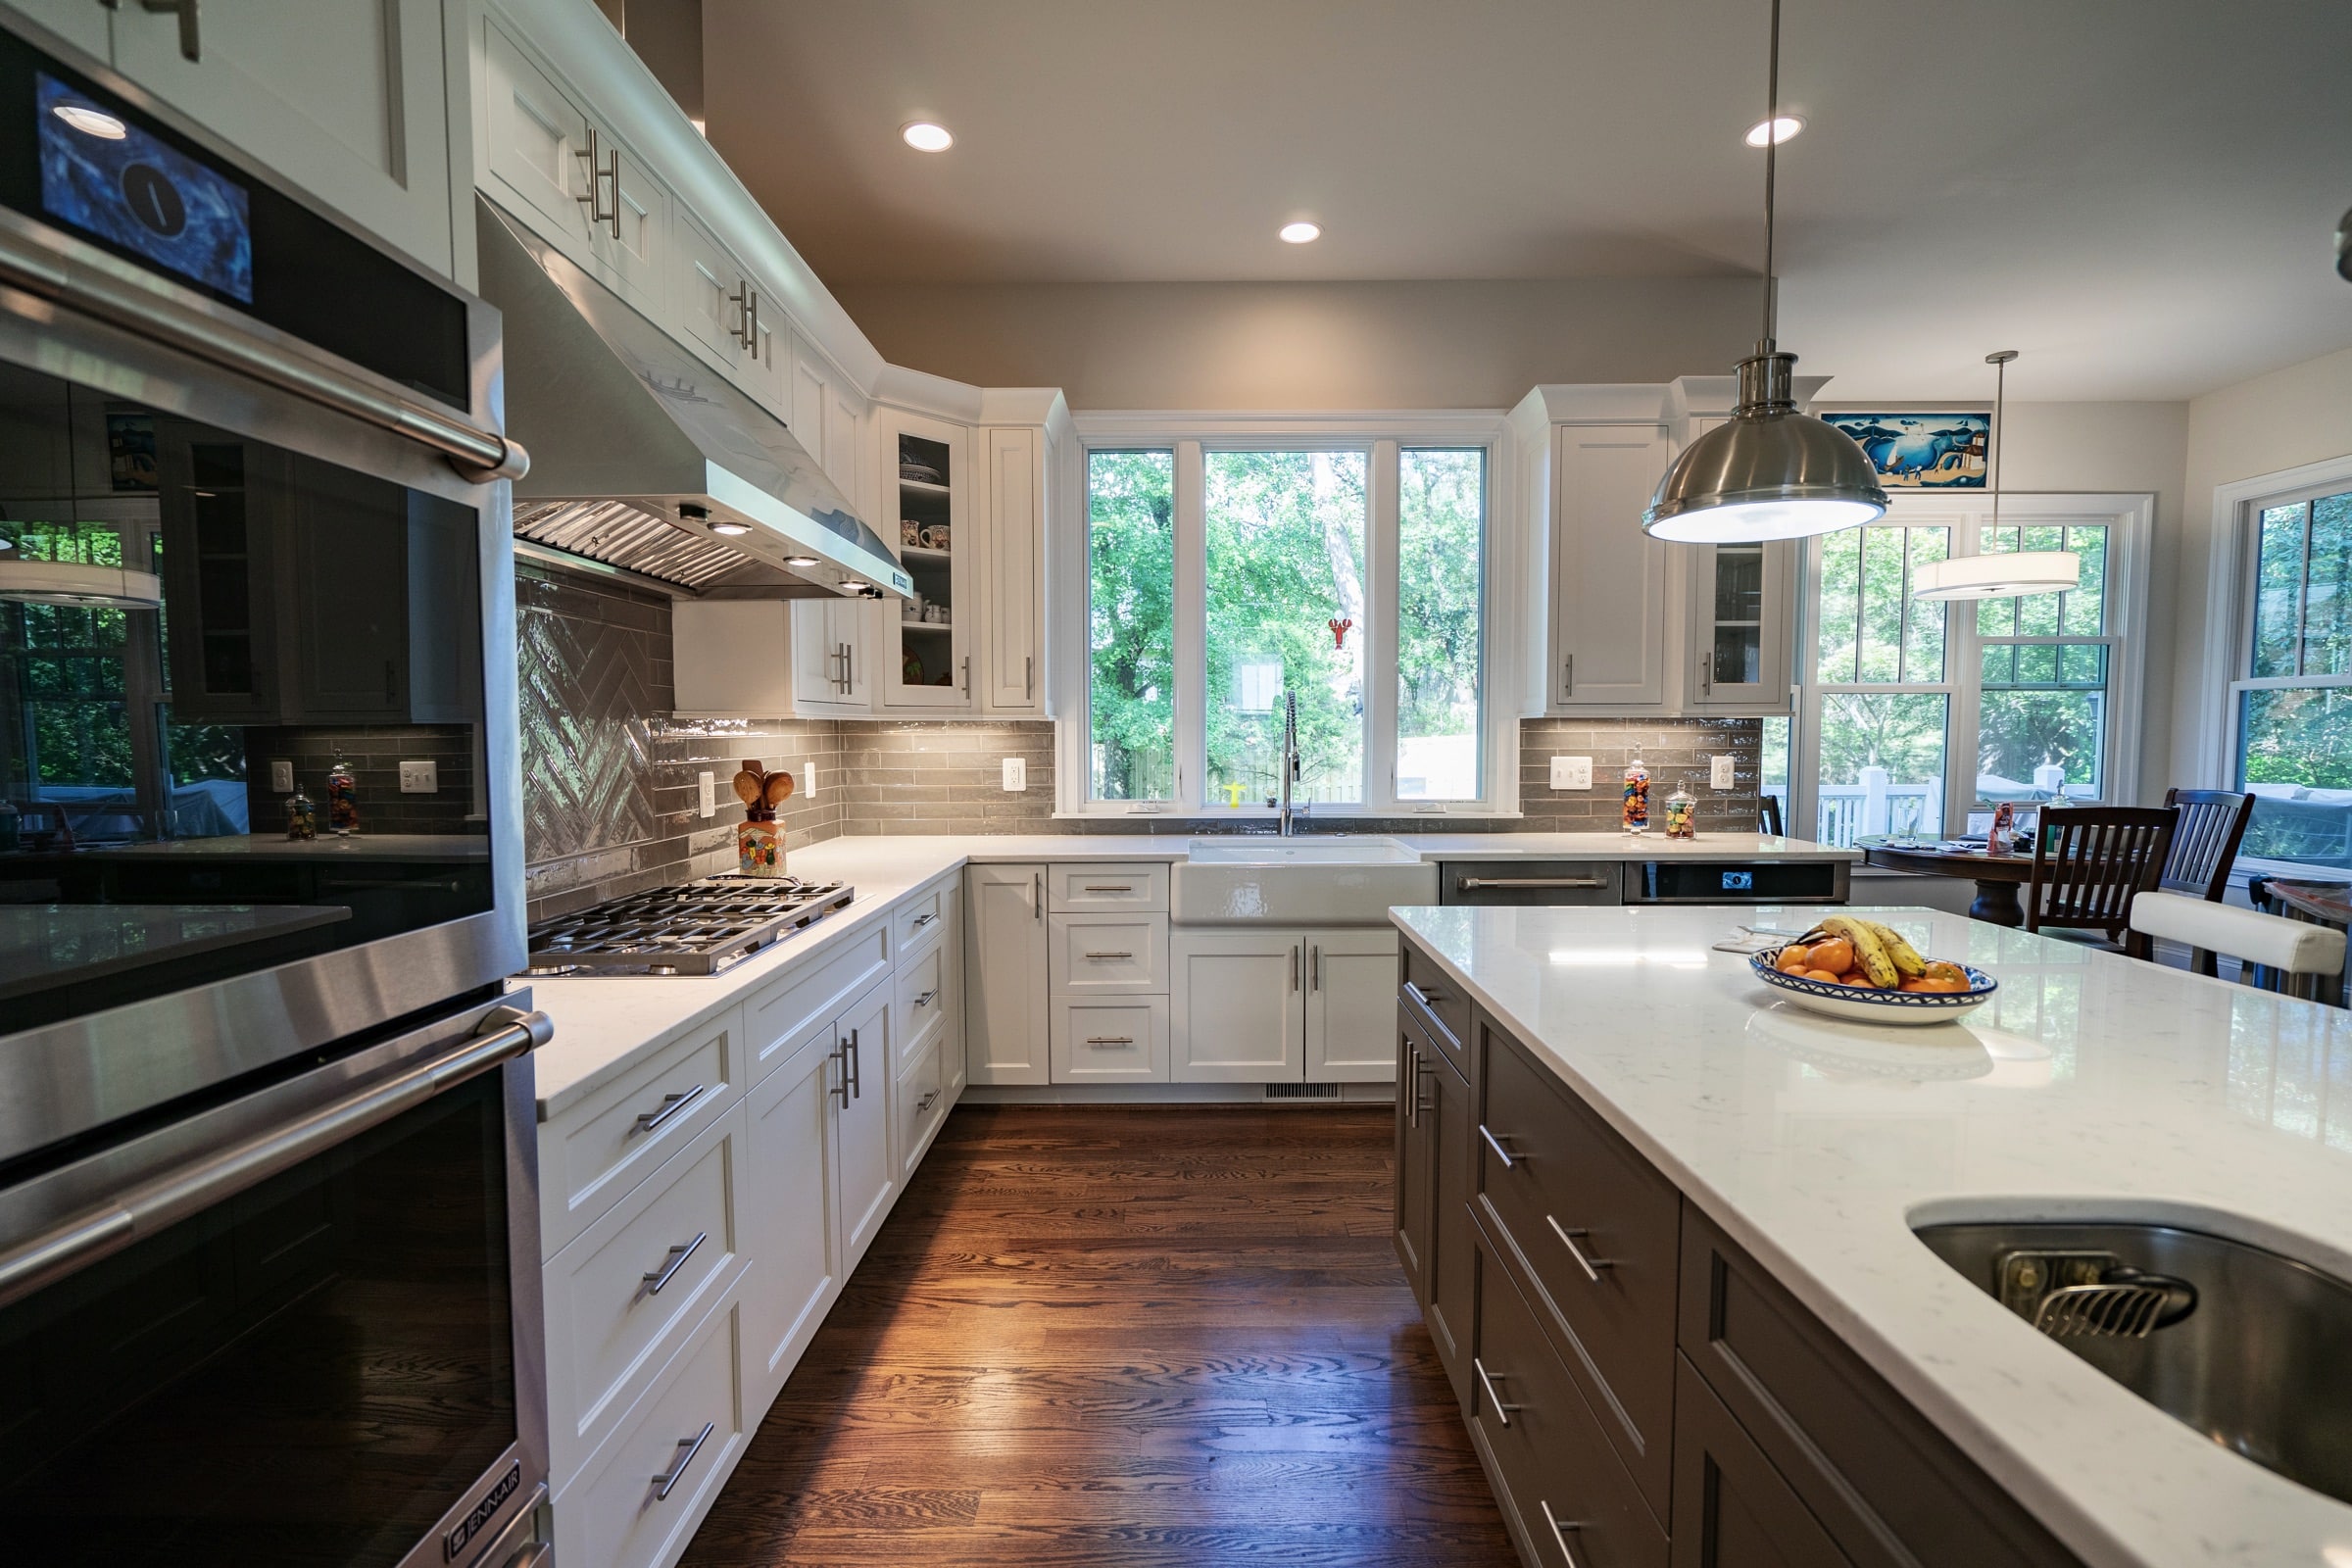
[1169,837,1437,926]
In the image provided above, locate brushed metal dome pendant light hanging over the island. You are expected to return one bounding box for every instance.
[1642,0,1886,546]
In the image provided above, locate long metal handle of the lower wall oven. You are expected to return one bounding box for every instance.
[0,1006,555,1307]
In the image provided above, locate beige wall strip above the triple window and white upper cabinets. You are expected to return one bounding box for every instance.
[835,277,1757,412]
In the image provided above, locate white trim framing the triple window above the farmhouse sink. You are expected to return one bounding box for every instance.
[1047,409,1519,825]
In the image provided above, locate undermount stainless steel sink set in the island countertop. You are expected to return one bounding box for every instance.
[1917,1222,2352,1502]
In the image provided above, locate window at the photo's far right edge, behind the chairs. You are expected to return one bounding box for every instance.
[2230,489,2352,867]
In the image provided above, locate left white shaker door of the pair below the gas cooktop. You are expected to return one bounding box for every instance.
[741,1020,847,1413]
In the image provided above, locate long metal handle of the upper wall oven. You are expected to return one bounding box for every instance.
[0,226,531,484]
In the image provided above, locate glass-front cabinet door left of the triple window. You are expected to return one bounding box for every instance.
[875,409,978,712]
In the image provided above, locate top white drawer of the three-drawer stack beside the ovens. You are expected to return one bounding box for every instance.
[539,1008,743,1257]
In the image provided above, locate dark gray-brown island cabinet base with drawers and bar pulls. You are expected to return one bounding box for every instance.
[1395,936,2077,1568]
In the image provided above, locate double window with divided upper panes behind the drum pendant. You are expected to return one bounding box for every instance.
[1766,496,2150,844]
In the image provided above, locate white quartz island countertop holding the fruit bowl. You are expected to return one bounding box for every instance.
[1393,903,2352,1568]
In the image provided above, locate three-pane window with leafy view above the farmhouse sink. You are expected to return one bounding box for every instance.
[1060,432,1507,815]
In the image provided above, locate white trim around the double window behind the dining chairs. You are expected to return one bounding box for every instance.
[1788,491,2157,837]
